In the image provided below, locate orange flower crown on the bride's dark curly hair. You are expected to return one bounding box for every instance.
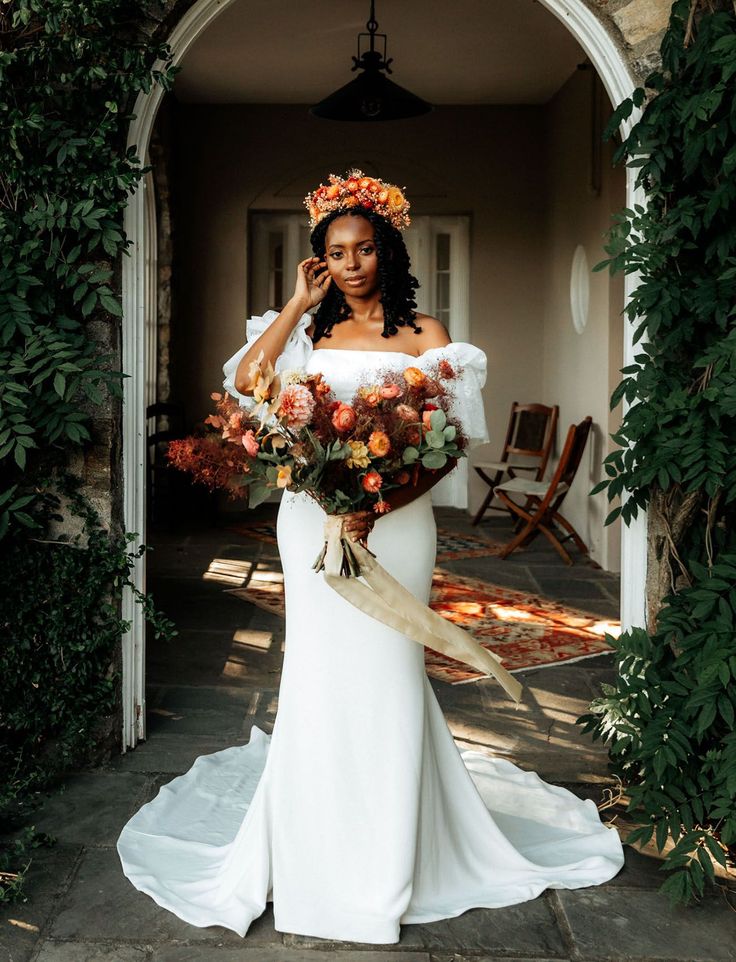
[304,168,411,230]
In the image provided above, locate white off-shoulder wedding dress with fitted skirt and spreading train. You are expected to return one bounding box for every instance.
[117,311,624,944]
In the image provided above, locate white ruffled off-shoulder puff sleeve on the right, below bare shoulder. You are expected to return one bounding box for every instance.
[417,341,490,451]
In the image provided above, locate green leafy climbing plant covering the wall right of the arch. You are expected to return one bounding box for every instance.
[578,0,736,902]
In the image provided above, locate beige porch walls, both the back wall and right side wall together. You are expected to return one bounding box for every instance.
[172,90,624,570]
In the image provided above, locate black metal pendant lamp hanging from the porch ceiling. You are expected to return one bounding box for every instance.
[309,0,434,121]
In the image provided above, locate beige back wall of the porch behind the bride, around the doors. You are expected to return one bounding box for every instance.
[172,105,544,509]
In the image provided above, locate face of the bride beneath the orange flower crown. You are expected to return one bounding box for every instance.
[325,214,378,297]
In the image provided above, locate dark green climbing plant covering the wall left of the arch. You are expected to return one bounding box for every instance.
[0,0,180,901]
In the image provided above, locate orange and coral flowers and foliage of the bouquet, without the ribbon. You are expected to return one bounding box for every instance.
[167,353,467,573]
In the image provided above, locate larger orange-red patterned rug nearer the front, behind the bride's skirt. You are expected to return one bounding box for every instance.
[228,568,620,685]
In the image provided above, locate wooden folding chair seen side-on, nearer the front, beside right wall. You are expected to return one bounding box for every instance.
[496,415,593,565]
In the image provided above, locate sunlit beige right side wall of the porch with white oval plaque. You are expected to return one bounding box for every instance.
[542,70,625,571]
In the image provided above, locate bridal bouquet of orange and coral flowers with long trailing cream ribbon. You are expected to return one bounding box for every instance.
[168,353,521,703]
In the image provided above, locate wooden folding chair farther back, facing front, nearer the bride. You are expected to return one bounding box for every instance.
[473,401,560,524]
